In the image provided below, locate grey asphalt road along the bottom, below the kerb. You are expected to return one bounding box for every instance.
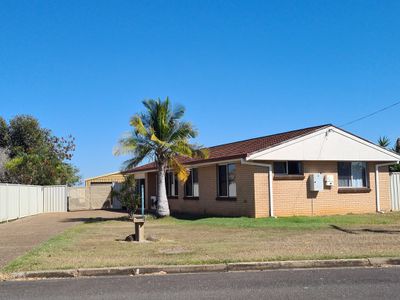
[0,267,400,300]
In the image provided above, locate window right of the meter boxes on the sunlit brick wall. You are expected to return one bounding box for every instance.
[338,161,368,188]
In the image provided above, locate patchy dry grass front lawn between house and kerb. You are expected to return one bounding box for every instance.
[3,213,400,272]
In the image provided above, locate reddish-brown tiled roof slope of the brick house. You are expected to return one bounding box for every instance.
[127,124,331,173]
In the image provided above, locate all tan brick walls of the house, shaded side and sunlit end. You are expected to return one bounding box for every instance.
[146,162,390,218]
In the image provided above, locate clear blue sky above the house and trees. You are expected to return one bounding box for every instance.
[0,0,400,177]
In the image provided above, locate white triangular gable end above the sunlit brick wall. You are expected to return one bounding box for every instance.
[246,126,400,163]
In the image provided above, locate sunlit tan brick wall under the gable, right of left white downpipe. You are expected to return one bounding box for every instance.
[273,162,390,216]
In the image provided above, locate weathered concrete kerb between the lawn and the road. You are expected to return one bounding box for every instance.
[4,258,400,280]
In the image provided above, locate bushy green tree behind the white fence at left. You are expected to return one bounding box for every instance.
[0,115,80,185]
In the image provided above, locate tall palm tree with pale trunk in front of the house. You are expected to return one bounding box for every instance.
[115,97,208,217]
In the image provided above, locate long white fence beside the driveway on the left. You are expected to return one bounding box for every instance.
[0,183,67,222]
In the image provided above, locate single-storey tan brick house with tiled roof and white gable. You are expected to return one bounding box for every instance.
[129,124,400,218]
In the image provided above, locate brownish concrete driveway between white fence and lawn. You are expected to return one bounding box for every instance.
[0,210,126,269]
